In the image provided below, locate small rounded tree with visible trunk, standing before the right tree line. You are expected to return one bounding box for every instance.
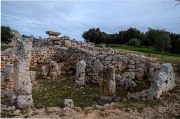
[154,31,171,58]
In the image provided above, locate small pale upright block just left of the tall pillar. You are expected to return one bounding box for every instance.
[4,64,14,81]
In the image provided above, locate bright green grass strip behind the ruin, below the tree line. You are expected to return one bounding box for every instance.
[111,46,180,64]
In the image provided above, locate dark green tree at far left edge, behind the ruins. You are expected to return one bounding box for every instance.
[1,26,14,43]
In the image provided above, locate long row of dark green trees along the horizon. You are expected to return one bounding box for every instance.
[82,27,180,54]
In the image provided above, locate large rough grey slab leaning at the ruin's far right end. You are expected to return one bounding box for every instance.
[147,63,175,100]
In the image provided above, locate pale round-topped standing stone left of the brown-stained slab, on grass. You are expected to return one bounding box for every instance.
[75,60,86,87]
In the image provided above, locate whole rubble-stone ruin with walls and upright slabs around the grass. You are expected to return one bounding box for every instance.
[1,32,175,108]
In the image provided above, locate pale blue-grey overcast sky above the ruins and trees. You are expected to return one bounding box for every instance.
[1,0,180,41]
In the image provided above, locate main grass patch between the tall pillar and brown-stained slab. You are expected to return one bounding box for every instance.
[32,72,100,108]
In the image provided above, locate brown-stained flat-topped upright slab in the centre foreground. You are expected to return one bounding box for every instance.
[99,66,116,103]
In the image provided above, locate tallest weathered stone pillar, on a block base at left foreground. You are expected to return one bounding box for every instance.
[11,38,33,108]
